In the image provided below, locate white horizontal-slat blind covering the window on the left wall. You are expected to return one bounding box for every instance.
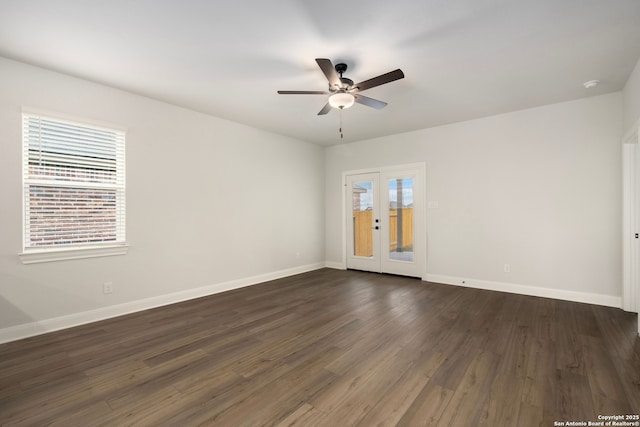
[22,114,125,252]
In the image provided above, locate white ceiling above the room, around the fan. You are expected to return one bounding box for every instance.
[0,0,640,145]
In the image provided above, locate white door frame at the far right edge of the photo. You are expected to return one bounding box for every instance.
[622,121,640,334]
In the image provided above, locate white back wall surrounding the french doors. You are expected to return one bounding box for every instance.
[325,92,622,307]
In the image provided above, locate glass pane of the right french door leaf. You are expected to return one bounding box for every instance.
[388,178,414,261]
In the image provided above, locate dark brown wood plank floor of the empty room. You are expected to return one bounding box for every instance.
[0,269,640,427]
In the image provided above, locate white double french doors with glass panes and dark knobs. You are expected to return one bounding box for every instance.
[345,168,426,277]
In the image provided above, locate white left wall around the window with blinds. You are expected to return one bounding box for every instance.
[0,59,324,341]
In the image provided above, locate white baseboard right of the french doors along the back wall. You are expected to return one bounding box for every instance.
[425,274,622,308]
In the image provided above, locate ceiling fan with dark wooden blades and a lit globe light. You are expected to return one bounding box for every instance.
[278,58,404,116]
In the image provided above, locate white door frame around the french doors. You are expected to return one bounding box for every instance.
[341,163,427,280]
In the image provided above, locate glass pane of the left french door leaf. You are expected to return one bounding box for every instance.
[351,181,374,257]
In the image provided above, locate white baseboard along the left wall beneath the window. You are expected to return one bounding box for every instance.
[0,262,325,344]
